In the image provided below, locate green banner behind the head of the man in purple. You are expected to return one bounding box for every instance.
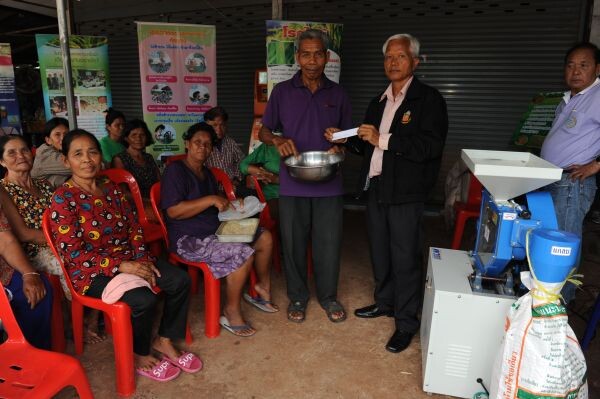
[266,20,344,94]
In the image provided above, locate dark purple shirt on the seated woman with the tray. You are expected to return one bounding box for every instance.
[160,160,220,251]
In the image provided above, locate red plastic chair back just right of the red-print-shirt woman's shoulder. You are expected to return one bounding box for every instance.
[100,168,163,256]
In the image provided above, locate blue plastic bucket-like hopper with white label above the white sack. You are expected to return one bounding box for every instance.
[529,229,581,283]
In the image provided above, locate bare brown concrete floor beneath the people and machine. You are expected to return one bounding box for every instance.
[59,211,600,399]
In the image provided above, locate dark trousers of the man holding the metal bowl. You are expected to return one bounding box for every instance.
[279,196,344,307]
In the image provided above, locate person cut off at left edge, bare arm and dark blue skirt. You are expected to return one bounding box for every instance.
[0,203,52,350]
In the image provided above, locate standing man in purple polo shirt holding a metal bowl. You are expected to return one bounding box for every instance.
[259,29,352,323]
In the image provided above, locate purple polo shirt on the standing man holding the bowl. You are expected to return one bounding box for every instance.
[262,71,352,197]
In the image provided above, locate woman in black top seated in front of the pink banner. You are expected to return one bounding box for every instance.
[112,119,160,222]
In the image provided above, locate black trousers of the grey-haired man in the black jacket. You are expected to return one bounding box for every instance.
[367,183,424,333]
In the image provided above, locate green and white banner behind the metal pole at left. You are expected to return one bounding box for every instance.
[35,35,112,138]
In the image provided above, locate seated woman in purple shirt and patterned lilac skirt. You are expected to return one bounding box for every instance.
[161,122,278,337]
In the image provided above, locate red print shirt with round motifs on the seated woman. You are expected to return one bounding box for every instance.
[50,178,154,295]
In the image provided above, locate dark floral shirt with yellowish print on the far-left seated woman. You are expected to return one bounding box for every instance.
[0,179,54,258]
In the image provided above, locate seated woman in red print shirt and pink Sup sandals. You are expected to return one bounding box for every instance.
[50,129,202,381]
